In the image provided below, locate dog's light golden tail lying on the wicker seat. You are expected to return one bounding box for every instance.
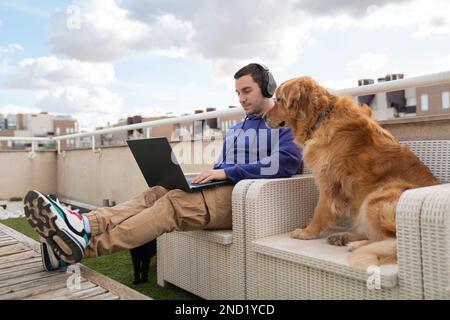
[349,238,397,268]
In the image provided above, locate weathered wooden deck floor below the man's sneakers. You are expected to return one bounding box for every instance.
[0,223,150,300]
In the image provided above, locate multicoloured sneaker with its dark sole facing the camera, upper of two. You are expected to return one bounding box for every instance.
[24,191,89,264]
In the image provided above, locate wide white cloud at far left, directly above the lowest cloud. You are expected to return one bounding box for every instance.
[4,56,115,89]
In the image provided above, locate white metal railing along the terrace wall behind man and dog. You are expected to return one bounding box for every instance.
[0,71,450,158]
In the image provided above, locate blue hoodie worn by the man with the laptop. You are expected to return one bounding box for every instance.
[214,115,303,183]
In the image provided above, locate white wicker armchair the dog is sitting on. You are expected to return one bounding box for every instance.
[245,141,450,299]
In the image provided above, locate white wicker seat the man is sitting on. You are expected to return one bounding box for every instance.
[157,180,254,299]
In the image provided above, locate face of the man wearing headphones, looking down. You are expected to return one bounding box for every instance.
[235,75,264,115]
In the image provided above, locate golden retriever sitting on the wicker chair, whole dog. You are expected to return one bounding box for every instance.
[265,77,438,268]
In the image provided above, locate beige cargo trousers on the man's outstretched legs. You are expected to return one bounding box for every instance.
[85,184,234,258]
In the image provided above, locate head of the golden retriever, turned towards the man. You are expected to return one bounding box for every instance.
[265,77,335,142]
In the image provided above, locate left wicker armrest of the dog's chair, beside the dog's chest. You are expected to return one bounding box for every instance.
[245,175,319,241]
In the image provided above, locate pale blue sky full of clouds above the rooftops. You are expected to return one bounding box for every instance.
[0,0,450,130]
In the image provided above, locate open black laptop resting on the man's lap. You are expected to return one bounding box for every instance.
[127,137,231,192]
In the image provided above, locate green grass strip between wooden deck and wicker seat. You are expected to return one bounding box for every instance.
[0,218,200,300]
